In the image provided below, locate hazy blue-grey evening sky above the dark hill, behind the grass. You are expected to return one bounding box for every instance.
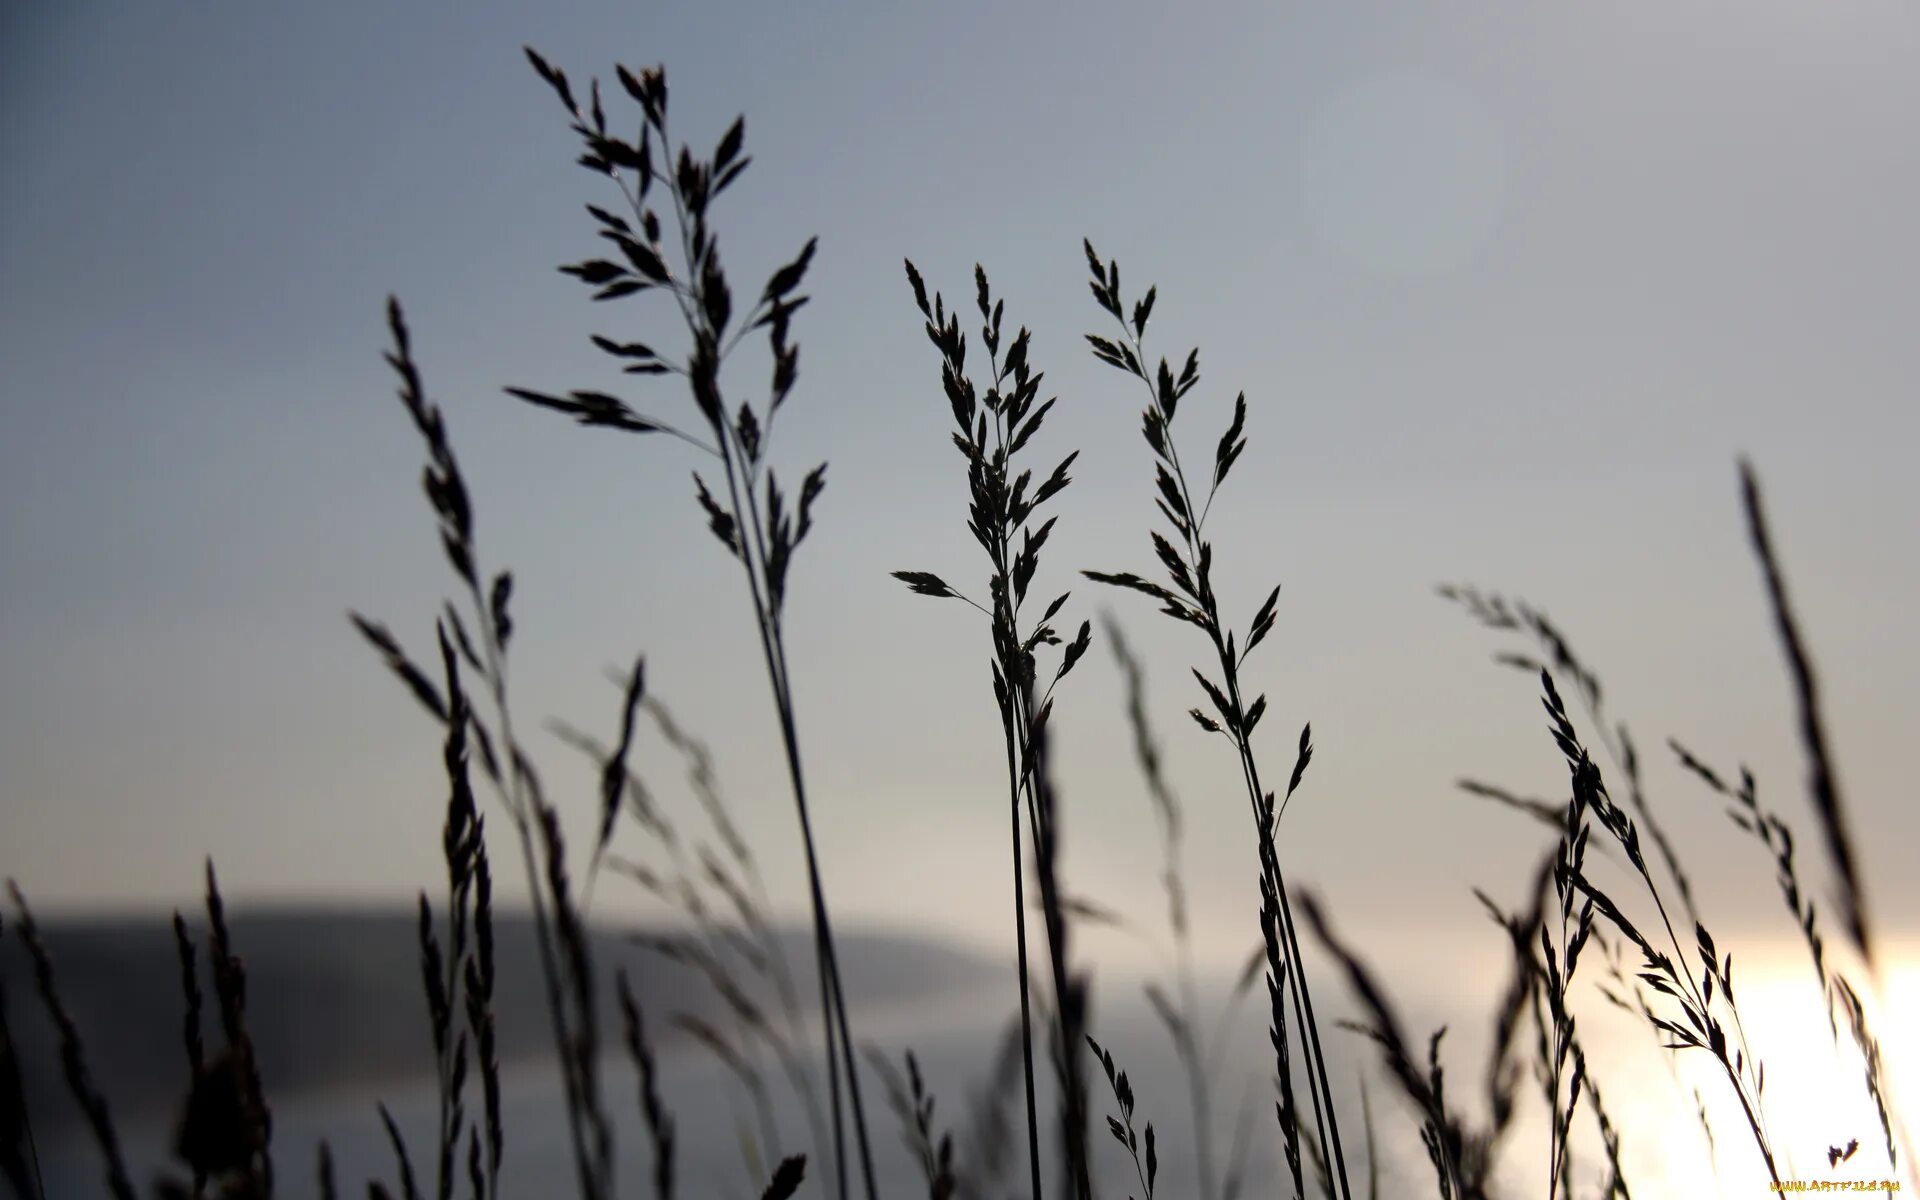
[0,0,1920,1182]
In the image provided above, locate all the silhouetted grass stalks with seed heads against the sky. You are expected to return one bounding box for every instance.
[0,42,1912,1200]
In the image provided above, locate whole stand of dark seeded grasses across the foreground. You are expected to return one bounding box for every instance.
[0,52,1914,1200]
